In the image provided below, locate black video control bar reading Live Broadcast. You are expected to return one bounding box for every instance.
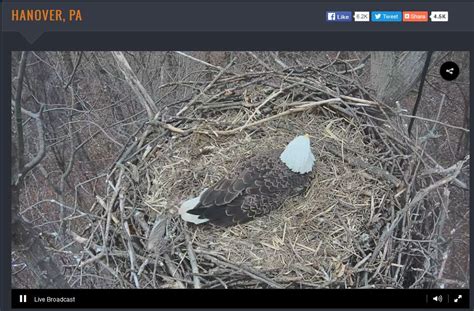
[11,289,469,309]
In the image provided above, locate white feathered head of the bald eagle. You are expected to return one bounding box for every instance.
[280,134,315,174]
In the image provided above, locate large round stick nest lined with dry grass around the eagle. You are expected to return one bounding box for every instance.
[75,61,465,288]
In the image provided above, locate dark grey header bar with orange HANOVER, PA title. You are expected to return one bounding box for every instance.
[2,1,474,41]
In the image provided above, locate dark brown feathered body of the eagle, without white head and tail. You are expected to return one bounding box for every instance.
[187,149,313,226]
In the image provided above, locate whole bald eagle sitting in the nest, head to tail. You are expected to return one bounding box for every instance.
[179,135,315,227]
